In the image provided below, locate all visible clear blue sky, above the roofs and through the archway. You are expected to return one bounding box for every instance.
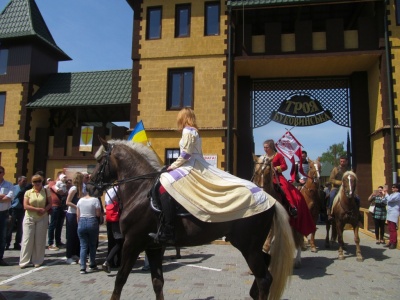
[0,0,349,172]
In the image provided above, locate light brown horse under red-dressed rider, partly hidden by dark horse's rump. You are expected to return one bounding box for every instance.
[252,154,304,268]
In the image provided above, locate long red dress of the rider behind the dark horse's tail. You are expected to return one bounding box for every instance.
[272,153,315,236]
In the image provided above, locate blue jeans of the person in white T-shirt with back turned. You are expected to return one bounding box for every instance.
[78,218,99,270]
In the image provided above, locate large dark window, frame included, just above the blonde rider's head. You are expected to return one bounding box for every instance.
[167,68,194,110]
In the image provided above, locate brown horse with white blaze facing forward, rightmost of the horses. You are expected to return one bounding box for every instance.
[325,171,363,261]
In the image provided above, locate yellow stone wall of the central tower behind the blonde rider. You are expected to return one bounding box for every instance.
[137,0,227,167]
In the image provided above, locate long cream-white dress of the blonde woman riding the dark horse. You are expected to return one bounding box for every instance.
[160,127,276,222]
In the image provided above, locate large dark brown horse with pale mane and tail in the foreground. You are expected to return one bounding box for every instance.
[88,140,294,300]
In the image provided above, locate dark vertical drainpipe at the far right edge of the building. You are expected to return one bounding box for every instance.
[383,0,397,183]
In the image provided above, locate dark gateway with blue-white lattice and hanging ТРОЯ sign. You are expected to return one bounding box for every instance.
[237,72,371,205]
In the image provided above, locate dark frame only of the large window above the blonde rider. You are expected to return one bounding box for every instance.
[167,67,195,111]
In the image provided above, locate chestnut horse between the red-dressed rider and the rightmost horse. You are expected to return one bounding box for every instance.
[300,157,325,252]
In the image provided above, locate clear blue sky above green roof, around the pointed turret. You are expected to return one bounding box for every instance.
[0,0,133,72]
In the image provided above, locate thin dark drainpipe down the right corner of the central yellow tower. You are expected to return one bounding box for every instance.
[226,5,233,173]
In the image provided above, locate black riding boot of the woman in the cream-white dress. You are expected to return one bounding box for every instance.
[149,192,175,244]
